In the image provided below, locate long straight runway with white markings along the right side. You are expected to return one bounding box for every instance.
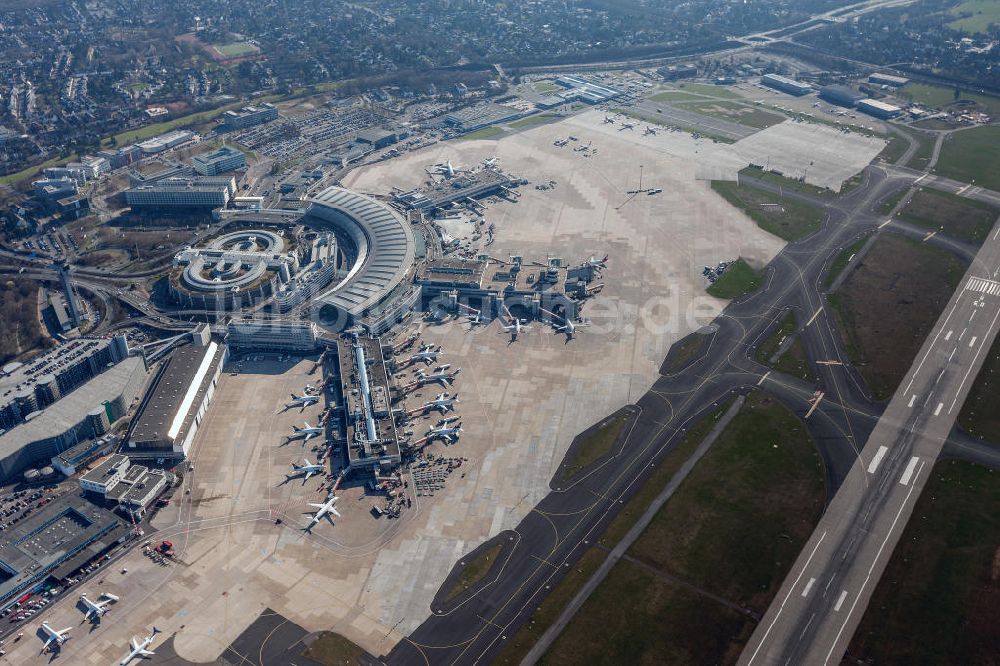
[740,219,1000,666]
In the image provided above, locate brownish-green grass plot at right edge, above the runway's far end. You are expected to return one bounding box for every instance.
[898,189,1000,245]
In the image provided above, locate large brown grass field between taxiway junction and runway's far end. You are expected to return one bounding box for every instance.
[828,233,966,400]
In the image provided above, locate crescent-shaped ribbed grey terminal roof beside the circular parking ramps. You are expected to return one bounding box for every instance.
[306,187,415,317]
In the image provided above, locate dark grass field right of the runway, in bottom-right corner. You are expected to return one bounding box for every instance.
[844,460,1000,666]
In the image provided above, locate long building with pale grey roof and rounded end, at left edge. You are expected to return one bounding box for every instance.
[0,356,147,483]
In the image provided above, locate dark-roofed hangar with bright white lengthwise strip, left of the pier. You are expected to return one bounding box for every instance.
[124,342,229,459]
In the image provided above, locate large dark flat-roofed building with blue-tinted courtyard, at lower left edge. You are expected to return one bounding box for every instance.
[0,493,134,607]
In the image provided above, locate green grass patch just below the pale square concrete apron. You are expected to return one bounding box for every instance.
[712,180,826,241]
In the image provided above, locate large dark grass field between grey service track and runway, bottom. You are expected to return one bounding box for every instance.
[542,392,826,665]
